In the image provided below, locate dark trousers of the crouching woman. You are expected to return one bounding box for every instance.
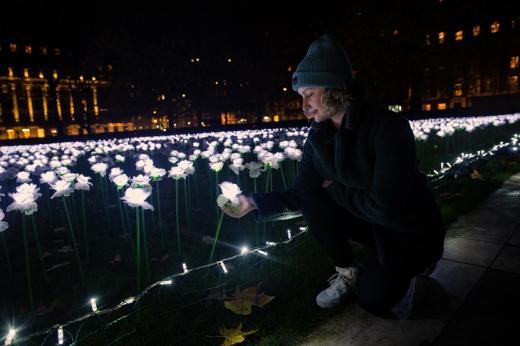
[302,189,438,315]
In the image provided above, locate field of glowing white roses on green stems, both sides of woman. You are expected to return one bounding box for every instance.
[0,114,520,344]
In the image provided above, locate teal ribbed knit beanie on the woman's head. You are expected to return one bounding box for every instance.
[292,34,354,91]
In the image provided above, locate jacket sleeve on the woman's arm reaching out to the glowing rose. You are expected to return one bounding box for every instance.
[252,142,323,222]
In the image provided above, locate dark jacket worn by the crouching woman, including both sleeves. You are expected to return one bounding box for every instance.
[253,101,445,264]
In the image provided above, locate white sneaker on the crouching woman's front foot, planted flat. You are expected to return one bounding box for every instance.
[316,267,358,309]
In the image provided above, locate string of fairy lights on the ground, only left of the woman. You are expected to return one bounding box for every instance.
[4,226,308,345]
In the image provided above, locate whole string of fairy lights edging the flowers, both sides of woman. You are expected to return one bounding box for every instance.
[4,134,520,345]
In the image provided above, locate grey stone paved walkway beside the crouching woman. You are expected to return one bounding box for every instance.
[300,173,520,346]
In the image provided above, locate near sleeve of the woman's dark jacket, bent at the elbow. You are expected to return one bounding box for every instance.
[327,117,416,230]
